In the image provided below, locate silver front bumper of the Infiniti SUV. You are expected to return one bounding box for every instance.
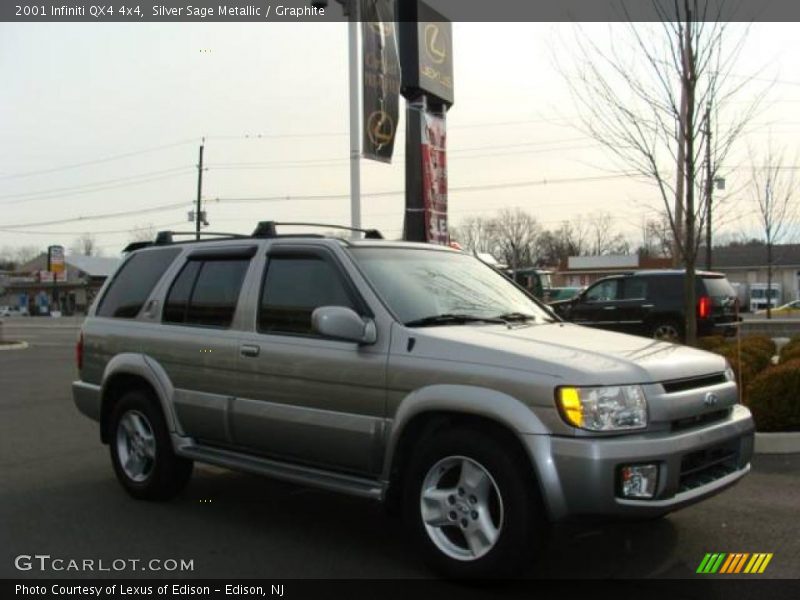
[525,405,754,521]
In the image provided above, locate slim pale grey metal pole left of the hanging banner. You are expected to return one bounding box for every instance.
[311,0,361,239]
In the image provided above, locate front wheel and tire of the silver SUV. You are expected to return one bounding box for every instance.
[403,428,548,579]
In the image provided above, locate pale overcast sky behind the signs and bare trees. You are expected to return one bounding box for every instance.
[0,23,800,255]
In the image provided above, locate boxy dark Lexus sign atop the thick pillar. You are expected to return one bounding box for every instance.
[400,0,455,107]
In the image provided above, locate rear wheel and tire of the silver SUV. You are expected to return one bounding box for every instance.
[109,390,193,500]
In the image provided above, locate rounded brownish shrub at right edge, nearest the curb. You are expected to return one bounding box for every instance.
[747,359,800,431]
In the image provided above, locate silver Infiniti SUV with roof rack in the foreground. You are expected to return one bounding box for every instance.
[72,222,753,577]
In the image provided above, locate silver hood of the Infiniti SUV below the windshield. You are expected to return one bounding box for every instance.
[407,323,726,385]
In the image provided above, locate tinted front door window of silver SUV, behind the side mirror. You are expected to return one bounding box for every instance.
[258,256,357,334]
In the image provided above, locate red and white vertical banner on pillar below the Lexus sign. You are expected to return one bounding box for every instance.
[419,110,450,245]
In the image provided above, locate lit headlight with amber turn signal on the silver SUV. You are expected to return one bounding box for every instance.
[556,385,647,431]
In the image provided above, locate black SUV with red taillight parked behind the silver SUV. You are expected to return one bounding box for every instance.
[551,270,739,341]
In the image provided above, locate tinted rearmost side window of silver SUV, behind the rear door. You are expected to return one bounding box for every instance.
[97,248,180,319]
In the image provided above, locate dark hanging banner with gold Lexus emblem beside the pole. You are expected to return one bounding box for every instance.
[360,0,400,162]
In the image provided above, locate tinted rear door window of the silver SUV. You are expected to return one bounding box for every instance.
[163,259,250,327]
